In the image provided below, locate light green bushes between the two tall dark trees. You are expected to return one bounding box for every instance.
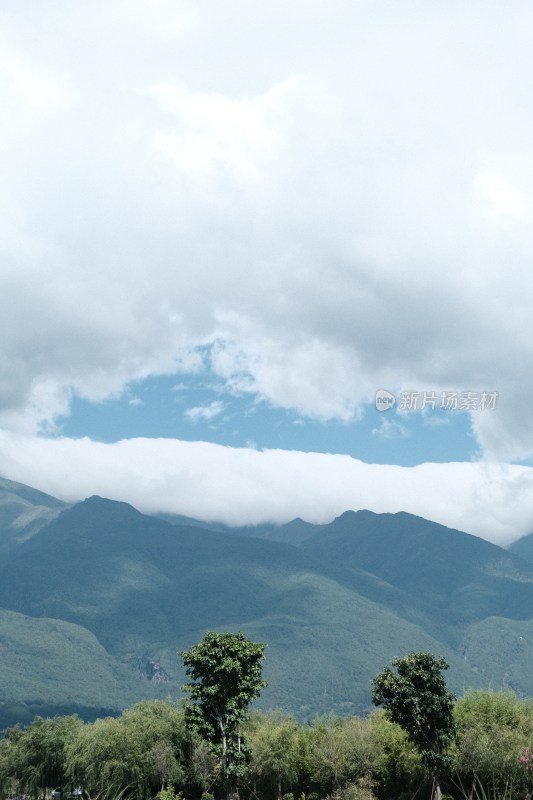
[249,712,425,800]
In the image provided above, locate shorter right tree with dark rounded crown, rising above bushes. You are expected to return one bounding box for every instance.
[372,653,455,800]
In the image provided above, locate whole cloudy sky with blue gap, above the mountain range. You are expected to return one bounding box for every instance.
[0,0,533,544]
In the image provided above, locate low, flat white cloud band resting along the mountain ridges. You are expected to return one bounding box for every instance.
[0,433,533,543]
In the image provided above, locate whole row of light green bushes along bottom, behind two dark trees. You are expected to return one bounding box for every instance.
[9,691,533,800]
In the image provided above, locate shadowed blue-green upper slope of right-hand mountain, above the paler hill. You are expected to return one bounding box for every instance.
[302,511,533,646]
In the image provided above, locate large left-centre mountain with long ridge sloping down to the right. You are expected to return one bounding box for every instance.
[0,498,478,716]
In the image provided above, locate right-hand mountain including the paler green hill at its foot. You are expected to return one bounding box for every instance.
[302,511,533,696]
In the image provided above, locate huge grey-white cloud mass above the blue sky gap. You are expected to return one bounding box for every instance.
[0,0,533,458]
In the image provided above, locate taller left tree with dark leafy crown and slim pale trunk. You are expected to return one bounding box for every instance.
[180,631,266,800]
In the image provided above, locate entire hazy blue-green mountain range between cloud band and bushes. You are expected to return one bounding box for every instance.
[0,480,533,725]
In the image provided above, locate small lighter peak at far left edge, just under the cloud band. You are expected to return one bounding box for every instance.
[0,478,67,556]
